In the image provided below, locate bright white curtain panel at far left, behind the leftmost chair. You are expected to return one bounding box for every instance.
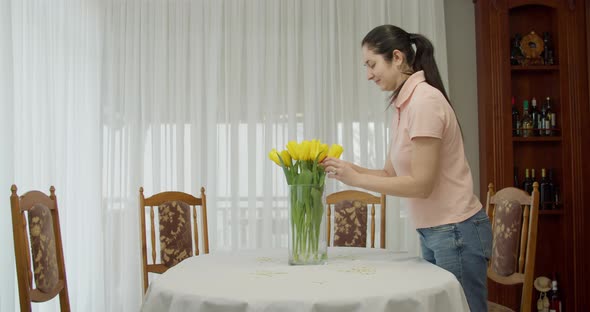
[0,0,105,311]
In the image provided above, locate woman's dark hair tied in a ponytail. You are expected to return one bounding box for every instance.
[361,25,453,107]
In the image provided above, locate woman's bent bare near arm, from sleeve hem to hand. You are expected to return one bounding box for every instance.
[326,137,441,198]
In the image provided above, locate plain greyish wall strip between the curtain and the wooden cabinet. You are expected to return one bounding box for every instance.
[445,0,481,199]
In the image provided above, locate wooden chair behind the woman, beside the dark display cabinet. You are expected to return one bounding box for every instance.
[486,182,539,312]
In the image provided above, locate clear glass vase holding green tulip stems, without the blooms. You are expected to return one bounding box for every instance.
[288,184,328,265]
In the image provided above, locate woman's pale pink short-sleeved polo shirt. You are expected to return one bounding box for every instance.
[390,71,482,228]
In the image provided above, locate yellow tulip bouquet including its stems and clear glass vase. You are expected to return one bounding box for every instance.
[268,140,343,264]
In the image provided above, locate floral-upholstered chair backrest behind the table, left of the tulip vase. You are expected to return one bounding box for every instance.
[139,187,209,293]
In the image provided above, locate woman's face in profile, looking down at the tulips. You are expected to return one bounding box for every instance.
[363,45,407,91]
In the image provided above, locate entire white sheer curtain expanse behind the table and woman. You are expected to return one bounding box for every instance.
[0,0,447,311]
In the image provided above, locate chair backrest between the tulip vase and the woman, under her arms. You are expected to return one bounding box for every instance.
[326,190,386,248]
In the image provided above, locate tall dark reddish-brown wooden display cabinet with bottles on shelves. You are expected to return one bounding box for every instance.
[473,0,590,311]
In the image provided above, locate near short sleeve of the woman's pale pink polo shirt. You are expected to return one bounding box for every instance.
[408,89,449,139]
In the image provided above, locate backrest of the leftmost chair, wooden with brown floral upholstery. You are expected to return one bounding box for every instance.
[10,185,70,311]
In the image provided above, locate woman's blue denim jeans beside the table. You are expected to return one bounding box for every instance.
[417,209,492,312]
